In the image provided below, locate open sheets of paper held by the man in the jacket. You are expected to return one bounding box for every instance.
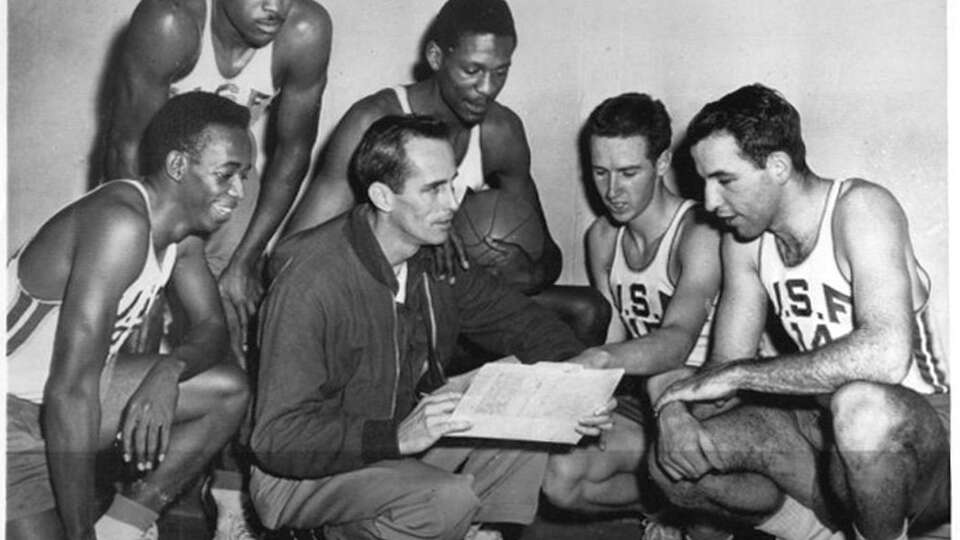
[447,358,623,444]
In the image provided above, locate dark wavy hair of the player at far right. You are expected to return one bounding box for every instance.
[687,83,809,173]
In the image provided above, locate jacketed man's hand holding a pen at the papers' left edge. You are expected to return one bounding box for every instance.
[397,392,471,456]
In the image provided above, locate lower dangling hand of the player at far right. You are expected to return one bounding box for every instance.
[657,403,716,481]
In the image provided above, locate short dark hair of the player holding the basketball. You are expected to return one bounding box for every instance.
[428,0,517,50]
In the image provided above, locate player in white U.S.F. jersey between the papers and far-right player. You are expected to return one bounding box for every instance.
[544,93,720,524]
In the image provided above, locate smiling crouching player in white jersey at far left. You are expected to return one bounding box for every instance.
[6,92,251,540]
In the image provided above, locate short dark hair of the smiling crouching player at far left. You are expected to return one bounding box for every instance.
[140,92,250,174]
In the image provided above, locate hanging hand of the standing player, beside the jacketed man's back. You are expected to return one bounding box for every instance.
[217,260,263,369]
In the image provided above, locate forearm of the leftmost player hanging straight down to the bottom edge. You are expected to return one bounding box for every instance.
[43,392,100,540]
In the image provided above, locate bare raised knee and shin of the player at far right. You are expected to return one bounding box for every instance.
[830,382,949,539]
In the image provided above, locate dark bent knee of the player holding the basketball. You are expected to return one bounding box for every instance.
[530,285,612,347]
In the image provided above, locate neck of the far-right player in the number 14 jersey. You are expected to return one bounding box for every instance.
[769,173,830,263]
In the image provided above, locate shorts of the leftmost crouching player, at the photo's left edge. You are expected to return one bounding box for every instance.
[7,394,56,521]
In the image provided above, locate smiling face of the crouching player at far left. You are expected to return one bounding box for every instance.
[181,125,251,233]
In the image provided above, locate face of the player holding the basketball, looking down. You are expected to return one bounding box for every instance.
[427,34,516,126]
